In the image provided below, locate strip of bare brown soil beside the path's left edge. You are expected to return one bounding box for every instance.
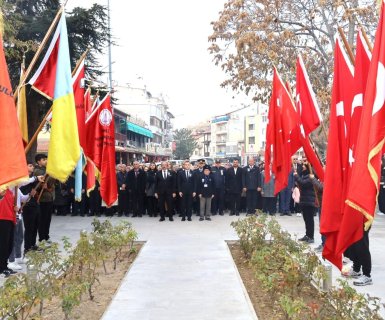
[30,243,143,320]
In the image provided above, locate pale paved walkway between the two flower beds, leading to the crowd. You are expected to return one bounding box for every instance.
[98,216,256,320]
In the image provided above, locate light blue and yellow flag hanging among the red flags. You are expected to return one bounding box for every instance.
[47,14,80,182]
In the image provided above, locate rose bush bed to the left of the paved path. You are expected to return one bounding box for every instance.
[0,220,138,319]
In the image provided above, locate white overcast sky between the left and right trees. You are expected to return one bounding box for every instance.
[67,0,247,128]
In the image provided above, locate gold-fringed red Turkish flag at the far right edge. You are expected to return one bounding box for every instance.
[346,2,385,251]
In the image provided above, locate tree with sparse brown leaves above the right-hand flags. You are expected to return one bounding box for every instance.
[209,0,378,118]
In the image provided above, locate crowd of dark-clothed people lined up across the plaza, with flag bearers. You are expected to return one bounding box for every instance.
[0,154,371,286]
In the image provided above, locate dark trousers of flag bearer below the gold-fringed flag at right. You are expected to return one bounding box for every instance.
[350,230,372,277]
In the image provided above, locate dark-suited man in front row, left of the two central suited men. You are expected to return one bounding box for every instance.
[155,161,176,221]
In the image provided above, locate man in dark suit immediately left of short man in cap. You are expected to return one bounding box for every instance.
[177,160,195,221]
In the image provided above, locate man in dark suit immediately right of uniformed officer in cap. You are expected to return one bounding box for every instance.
[225,160,243,216]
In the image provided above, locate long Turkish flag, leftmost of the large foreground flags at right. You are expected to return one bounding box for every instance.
[320,39,354,269]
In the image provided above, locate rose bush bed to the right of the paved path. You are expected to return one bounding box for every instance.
[230,215,382,320]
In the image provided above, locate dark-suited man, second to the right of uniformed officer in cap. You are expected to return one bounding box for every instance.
[243,158,261,215]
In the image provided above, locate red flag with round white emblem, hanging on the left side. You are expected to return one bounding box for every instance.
[85,93,118,206]
